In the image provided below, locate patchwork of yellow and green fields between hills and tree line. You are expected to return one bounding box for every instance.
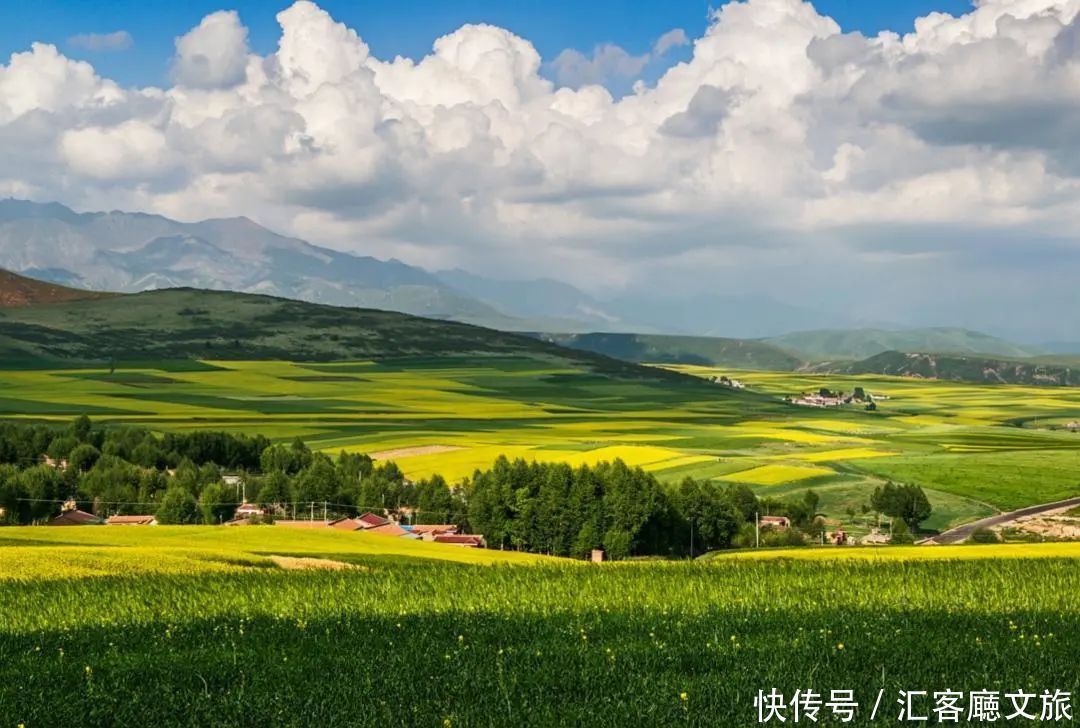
[0,355,1080,529]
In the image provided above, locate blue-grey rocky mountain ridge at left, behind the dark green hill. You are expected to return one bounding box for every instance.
[0,200,525,328]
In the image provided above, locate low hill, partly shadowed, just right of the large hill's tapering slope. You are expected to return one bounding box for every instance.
[536,334,802,372]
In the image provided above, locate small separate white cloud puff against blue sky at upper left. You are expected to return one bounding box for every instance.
[173,11,247,89]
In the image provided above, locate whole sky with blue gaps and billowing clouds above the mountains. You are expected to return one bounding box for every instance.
[0,0,1080,338]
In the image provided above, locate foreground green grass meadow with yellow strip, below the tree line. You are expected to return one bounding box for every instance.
[0,526,1080,728]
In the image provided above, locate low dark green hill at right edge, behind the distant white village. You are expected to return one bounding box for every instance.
[815,351,1080,387]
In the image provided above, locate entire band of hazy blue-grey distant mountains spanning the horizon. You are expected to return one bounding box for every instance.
[0,200,1080,361]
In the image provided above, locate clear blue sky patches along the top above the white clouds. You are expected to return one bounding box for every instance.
[0,0,971,85]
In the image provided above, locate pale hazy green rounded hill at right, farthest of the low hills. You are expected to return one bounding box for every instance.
[764,327,1044,361]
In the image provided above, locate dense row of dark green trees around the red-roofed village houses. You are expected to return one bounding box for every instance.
[0,417,924,558]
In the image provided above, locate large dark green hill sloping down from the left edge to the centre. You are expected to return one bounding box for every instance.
[0,288,692,381]
